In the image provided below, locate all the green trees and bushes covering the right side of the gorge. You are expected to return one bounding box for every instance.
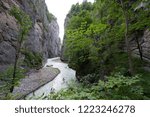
[50,0,150,99]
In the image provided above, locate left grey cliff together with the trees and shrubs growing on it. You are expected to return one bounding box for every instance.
[0,0,60,99]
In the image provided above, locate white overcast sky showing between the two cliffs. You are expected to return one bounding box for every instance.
[45,0,94,40]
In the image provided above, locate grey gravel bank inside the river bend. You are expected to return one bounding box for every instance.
[13,67,60,99]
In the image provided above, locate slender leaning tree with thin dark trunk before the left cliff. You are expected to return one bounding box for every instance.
[10,6,32,92]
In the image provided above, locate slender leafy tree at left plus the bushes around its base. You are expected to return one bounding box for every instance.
[0,6,32,96]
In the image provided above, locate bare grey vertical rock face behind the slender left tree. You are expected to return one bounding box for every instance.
[0,0,60,70]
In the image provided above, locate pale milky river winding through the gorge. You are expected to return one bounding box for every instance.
[25,57,76,99]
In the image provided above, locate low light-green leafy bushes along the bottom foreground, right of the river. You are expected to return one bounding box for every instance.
[48,74,146,100]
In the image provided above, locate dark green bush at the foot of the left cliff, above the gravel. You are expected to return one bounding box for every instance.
[22,50,42,69]
